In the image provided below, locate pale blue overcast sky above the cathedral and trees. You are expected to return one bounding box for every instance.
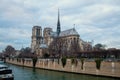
[0,0,120,52]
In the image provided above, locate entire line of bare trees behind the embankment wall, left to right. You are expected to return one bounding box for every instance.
[0,42,120,58]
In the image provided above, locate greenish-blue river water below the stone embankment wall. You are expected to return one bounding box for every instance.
[3,64,118,80]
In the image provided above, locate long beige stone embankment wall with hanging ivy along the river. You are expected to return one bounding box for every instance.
[6,59,120,78]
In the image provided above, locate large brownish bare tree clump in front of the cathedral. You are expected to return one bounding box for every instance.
[49,37,80,57]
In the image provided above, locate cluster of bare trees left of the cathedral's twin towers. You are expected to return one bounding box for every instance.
[0,45,35,58]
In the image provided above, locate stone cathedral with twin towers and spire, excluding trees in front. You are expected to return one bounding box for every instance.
[31,11,92,57]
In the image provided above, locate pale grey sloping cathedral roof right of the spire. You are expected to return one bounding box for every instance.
[59,28,79,37]
